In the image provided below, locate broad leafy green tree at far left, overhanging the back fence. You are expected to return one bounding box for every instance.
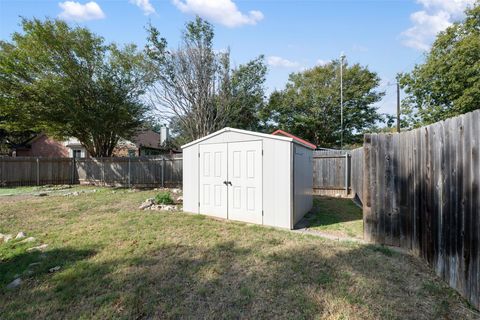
[0,19,151,157]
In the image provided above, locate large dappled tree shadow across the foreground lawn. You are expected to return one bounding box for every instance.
[0,241,474,319]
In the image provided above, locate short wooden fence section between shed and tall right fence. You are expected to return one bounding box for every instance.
[313,148,363,199]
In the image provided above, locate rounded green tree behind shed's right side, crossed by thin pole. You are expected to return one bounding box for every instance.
[261,61,384,147]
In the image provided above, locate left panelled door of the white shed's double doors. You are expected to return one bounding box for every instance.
[199,143,228,218]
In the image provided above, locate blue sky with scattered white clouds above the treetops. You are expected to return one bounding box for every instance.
[0,0,474,114]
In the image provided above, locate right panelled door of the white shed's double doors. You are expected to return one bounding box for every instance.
[228,141,263,224]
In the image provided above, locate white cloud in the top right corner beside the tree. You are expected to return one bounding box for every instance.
[401,0,475,50]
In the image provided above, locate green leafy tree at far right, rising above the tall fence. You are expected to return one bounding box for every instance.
[399,2,480,127]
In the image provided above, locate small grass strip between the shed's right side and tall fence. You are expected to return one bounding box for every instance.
[305,196,363,239]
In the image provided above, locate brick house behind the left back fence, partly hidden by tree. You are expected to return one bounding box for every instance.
[12,127,169,158]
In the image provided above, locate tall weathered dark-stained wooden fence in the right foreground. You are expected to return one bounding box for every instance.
[363,110,480,308]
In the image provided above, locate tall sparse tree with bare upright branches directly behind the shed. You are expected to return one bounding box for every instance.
[146,17,266,141]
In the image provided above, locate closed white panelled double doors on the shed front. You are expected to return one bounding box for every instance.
[199,141,263,224]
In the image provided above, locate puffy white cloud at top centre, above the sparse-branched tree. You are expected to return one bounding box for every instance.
[172,0,263,28]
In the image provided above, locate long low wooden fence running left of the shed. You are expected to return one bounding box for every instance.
[0,157,182,187]
